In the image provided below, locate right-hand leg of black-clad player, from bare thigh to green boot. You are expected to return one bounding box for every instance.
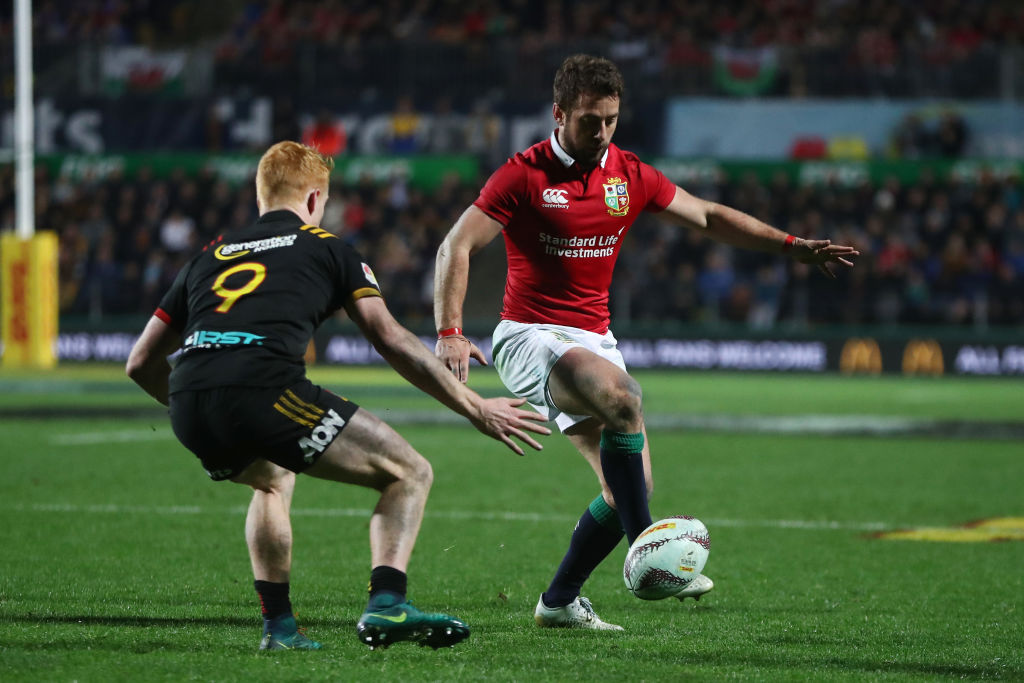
[304,409,469,648]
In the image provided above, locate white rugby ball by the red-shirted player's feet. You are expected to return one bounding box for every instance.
[623,515,711,600]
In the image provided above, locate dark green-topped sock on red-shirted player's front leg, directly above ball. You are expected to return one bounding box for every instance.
[601,429,651,543]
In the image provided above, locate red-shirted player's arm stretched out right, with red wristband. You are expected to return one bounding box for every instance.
[665,187,860,278]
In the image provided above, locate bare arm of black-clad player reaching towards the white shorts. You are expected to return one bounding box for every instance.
[346,297,551,456]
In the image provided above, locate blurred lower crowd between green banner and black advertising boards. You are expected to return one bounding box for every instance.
[0,160,1024,328]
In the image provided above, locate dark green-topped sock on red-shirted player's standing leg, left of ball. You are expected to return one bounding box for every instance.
[542,495,623,607]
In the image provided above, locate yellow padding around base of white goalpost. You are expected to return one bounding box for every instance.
[0,232,57,368]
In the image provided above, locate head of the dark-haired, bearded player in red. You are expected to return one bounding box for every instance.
[552,54,626,167]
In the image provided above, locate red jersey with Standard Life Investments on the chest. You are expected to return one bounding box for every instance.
[473,134,676,334]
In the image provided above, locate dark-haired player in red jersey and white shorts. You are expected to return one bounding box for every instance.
[434,55,858,630]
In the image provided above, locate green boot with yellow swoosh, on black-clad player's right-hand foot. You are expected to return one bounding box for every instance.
[355,600,469,650]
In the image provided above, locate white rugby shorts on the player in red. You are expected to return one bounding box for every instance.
[492,321,626,432]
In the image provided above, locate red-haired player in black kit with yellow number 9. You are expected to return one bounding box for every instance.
[126,141,550,649]
